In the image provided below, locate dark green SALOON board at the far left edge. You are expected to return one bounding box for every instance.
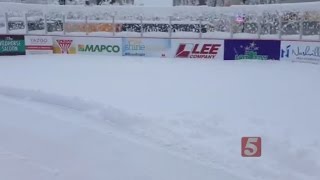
[0,35,26,56]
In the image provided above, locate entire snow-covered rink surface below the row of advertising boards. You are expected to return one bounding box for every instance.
[0,55,320,180]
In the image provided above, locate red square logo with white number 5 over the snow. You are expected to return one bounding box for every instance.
[241,137,261,157]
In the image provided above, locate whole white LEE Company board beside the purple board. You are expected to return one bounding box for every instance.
[172,39,224,60]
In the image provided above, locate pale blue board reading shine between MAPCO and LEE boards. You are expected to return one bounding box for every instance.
[122,38,171,57]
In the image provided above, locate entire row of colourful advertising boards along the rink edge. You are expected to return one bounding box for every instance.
[0,35,320,64]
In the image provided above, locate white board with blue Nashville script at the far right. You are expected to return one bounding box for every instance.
[280,41,320,64]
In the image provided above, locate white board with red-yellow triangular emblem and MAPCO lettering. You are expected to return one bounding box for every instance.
[53,36,122,56]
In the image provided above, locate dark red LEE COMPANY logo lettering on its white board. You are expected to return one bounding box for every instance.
[175,43,221,59]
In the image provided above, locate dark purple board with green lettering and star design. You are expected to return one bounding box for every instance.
[224,40,281,60]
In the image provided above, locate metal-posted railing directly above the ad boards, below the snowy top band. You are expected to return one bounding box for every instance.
[0,13,320,40]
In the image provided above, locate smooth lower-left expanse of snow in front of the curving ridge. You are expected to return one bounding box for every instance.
[0,94,238,180]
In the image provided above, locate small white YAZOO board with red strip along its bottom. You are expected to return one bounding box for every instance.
[25,36,53,54]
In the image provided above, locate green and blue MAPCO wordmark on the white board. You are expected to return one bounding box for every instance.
[78,44,120,53]
